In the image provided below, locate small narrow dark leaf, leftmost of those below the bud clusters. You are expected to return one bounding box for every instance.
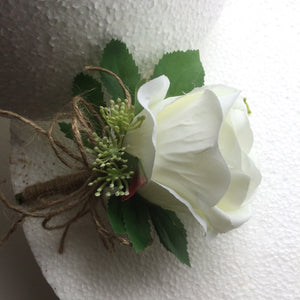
[107,197,126,233]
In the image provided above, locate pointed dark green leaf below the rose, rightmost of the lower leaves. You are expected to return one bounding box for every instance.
[149,204,191,267]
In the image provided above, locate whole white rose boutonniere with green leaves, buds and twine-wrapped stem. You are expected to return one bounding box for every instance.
[0,40,261,265]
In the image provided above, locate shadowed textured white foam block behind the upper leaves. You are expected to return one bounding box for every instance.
[0,0,225,117]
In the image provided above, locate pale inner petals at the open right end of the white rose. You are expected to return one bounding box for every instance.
[204,93,261,232]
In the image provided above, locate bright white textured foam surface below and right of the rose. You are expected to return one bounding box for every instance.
[4,0,300,300]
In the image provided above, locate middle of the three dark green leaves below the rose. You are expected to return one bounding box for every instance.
[123,194,151,253]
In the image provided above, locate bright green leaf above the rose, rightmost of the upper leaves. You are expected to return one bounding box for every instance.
[151,50,204,97]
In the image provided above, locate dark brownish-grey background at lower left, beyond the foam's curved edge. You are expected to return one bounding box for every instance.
[0,118,57,300]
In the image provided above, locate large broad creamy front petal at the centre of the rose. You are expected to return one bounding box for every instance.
[152,89,230,209]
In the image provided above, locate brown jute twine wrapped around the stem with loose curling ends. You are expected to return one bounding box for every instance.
[0,66,131,253]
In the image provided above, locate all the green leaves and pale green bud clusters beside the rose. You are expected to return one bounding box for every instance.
[59,40,204,266]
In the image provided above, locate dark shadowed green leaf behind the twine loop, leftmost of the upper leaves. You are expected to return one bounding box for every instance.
[72,73,105,109]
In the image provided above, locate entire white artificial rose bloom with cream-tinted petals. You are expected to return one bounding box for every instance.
[125,76,261,232]
